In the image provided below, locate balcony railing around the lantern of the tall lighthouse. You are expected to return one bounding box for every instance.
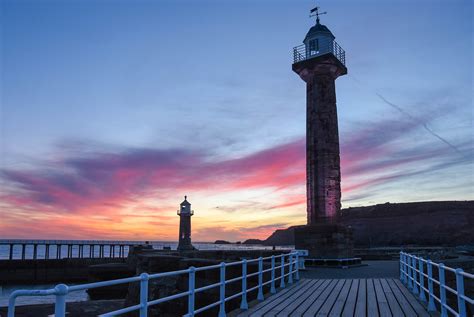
[293,41,346,66]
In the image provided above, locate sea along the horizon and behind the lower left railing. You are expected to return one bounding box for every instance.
[0,239,291,307]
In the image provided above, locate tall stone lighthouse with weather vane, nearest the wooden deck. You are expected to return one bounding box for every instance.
[292,7,352,258]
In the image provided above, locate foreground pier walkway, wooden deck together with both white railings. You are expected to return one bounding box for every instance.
[8,251,474,317]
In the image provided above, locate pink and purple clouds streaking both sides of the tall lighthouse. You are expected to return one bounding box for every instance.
[0,112,472,237]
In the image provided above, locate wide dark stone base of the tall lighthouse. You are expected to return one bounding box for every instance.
[295,223,354,259]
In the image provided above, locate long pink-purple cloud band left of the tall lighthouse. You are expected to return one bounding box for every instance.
[2,140,304,213]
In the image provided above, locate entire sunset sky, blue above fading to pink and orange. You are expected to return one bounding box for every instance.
[0,0,474,241]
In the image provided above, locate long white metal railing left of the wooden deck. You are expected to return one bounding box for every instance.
[8,251,303,317]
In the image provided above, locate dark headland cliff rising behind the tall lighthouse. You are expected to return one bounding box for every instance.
[264,201,474,247]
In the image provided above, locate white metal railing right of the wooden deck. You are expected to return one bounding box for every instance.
[400,252,474,317]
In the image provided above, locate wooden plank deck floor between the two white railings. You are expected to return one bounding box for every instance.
[238,279,430,317]
